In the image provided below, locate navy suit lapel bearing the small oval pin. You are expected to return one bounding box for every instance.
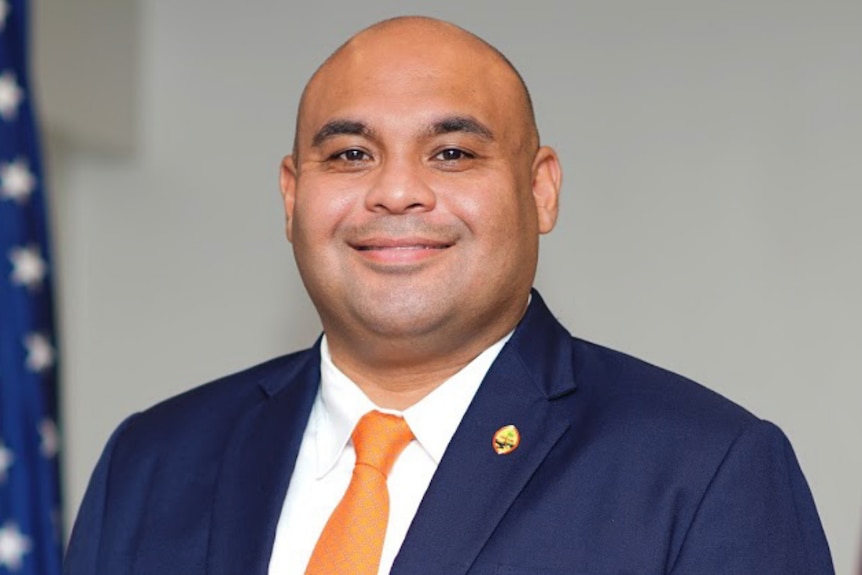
[392,292,575,575]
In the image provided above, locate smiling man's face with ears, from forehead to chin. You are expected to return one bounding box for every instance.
[282,23,559,356]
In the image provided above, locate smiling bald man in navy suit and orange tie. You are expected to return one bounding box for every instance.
[67,18,832,575]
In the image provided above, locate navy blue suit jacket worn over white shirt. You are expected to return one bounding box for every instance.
[65,292,833,575]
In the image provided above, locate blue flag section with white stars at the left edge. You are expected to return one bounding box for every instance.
[0,0,61,575]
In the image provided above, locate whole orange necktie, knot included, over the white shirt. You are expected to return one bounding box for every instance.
[305,411,413,575]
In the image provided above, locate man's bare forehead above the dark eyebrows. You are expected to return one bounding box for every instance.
[298,31,525,146]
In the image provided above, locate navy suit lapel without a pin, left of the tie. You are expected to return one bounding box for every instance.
[207,345,320,575]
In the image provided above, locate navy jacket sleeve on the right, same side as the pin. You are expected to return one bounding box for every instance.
[670,421,835,575]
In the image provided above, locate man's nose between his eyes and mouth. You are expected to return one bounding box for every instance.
[365,158,437,214]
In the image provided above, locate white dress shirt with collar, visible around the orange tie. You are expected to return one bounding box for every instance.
[269,332,512,575]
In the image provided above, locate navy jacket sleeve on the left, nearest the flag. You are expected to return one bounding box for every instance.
[63,415,135,575]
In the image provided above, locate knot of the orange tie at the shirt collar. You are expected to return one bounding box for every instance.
[352,411,413,475]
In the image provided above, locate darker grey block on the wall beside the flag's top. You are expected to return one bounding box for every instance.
[31,0,140,155]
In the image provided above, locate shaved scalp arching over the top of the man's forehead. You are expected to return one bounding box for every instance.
[293,16,539,159]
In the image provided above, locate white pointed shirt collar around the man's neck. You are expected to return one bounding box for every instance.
[315,330,514,479]
